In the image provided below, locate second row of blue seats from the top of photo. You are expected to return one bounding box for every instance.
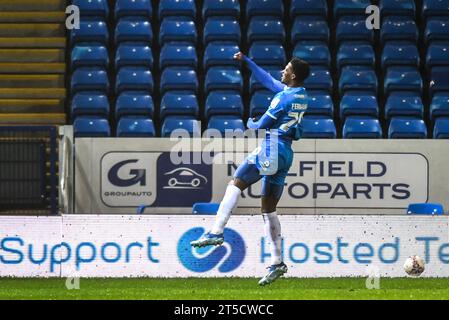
[70,16,449,46]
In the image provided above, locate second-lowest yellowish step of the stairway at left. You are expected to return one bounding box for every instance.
[0,99,64,113]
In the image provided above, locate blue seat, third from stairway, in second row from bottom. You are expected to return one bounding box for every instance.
[159,91,200,119]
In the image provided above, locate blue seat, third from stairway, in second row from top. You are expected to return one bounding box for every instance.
[159,17,198,46]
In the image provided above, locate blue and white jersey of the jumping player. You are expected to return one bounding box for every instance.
[266,87,308,141]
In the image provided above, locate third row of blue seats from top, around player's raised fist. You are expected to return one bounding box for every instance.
[71,41,449,71]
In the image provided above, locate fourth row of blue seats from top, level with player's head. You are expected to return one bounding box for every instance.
[71,66,449,97]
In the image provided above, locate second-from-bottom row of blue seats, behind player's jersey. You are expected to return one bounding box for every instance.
[71,90,449,122]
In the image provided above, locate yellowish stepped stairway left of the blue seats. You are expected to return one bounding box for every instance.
[0,0,66,125]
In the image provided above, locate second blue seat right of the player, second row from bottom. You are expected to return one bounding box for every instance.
[340,92,379,120]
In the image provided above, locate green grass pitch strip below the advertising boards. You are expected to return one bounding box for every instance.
[0,278,449,300]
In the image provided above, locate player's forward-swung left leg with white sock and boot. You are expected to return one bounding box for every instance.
[190,160,261,247]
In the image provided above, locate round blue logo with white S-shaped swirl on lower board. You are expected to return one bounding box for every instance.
[178,228,246,273]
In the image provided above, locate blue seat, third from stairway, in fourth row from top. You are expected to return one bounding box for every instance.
[160,68,198,94]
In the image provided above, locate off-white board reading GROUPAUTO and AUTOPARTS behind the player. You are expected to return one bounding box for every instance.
[73,138,449,215]
